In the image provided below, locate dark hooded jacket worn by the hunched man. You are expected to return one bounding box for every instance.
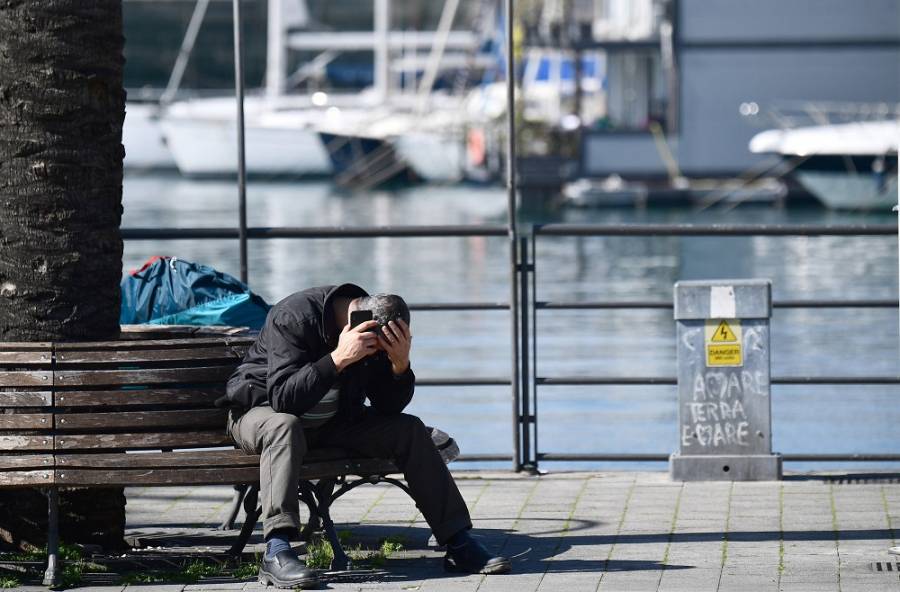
[216,284,415,417]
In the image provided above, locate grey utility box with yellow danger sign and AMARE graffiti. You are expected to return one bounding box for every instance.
[669,280,781,481]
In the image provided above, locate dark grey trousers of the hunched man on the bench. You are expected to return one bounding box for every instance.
[228,407,472,544]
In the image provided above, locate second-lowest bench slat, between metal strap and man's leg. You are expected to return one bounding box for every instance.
[56,450,259,469]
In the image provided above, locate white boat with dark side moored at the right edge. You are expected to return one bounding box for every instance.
[750,119,900,210]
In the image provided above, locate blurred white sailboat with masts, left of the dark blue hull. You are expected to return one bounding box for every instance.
[161,0,477,176]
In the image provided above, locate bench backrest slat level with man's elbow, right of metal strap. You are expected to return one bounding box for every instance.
[54,364,234,386]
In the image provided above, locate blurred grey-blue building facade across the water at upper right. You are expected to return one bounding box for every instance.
[582,0,900,177]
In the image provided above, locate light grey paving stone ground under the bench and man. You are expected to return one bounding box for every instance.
[15,472,900,592]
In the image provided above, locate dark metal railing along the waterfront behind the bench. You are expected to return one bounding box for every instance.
[122,224,900,470]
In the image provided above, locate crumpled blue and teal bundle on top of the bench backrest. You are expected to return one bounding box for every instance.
[119,257,270,331]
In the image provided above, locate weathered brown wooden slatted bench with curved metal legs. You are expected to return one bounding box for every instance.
[0,327,409,587]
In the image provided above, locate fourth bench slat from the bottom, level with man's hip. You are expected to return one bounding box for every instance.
[55,409,228,432]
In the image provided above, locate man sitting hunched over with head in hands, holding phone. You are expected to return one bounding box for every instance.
[219,284,510,587]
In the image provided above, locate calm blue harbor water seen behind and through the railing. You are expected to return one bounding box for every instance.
[122,175,900,470]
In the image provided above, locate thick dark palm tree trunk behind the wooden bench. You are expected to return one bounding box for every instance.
[0,0,125,545]
